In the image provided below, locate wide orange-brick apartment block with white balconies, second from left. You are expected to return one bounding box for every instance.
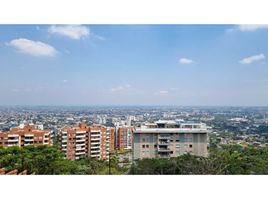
[59,124,115,160]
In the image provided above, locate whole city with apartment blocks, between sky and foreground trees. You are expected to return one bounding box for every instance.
[0,106,268,173]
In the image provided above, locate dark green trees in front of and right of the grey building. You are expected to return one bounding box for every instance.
[129,145,268,175]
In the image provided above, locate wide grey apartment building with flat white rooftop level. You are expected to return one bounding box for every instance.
[133,120,210,160]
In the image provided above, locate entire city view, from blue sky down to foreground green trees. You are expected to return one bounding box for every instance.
[0,25,268,175]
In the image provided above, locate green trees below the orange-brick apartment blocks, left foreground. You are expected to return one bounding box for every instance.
[0,146,126,175]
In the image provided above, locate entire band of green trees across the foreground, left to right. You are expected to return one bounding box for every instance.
[0,145,268,175]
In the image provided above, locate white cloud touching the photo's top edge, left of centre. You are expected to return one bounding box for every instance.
[48,25,90,40]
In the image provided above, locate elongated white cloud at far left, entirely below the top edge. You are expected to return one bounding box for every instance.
[6,38,57,57]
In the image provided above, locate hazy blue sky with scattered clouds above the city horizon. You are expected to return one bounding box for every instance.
[0,25,268,106]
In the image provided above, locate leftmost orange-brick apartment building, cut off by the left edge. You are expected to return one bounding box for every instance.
[0,124,52,147]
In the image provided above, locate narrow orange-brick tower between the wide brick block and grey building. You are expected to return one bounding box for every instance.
[116,126,134,151]
